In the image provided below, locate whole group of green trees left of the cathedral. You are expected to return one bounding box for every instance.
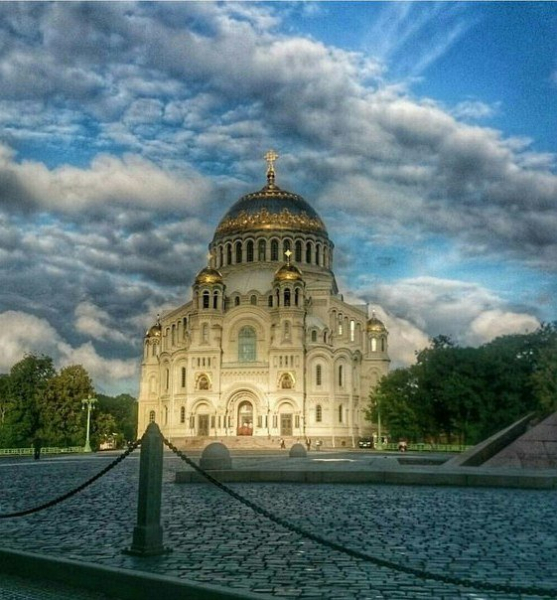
[0,354,137,449]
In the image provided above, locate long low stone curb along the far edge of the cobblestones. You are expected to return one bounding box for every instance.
[175,467,557,490]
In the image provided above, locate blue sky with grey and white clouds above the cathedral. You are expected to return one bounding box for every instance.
[0,2,557,393]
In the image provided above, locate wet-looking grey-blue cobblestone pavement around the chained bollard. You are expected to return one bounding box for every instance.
[0,452,557,600]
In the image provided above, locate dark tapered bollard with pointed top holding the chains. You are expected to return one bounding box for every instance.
[124,423,169,556]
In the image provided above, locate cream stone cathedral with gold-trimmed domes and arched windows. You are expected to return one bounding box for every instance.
[138,151,390,447]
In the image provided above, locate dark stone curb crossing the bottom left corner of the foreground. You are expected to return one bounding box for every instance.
[0,548,270,600]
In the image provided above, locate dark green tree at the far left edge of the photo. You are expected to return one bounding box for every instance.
[0,354,56,448]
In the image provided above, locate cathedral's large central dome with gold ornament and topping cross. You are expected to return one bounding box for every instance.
[215,155,328,243]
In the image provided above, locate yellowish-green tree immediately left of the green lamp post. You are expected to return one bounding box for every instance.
[41,365,93,447]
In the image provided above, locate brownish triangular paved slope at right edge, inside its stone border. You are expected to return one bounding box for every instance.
[483,413,557,469]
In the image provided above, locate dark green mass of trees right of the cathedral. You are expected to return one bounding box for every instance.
[368,322,557,444]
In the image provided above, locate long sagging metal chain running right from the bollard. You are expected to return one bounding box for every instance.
[163,437,557,598]
